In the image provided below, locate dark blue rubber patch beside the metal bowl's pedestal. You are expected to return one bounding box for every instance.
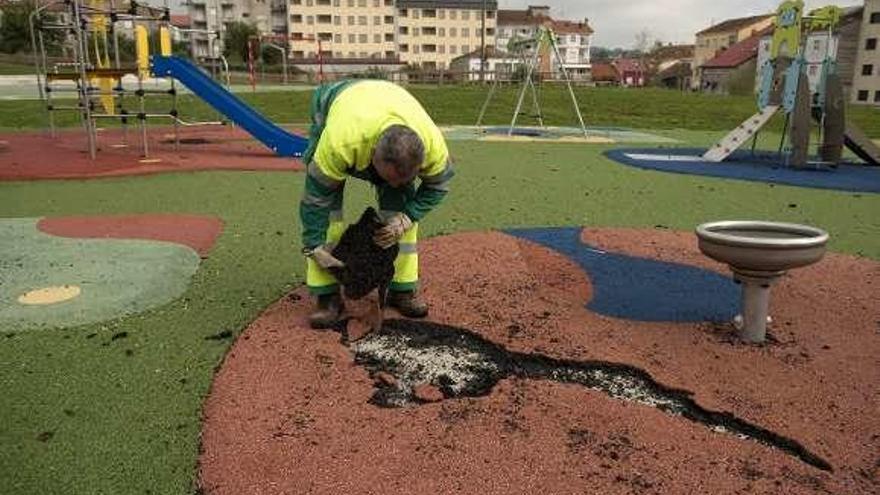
[505,227,740,322]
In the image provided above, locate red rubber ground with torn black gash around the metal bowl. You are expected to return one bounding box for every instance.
[199,229,880,495]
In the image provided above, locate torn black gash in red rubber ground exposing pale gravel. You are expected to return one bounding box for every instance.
[353,320,832,471]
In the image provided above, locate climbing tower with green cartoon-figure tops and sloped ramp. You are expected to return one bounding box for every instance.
[703,0,880,168]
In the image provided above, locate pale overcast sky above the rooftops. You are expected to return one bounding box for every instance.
[498,0,863,48]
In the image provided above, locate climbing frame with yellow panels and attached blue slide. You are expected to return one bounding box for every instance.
[31,0,308,158]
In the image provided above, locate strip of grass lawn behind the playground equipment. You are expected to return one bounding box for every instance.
[0,85,880,138]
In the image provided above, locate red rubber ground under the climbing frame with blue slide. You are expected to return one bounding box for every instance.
[0,126,304,180]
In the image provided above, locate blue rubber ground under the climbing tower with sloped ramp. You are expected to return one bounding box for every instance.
[605,148,880,193]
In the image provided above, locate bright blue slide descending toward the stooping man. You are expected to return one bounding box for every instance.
[152,55,309,156]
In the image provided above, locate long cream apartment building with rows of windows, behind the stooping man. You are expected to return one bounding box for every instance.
[288,0,497,69]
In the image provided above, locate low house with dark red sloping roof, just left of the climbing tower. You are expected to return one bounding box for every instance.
[700,26,773,94]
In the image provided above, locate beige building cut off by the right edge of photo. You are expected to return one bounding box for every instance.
[850,0,880,106]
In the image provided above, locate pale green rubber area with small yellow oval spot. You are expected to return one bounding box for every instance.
[0,218,200,331]
